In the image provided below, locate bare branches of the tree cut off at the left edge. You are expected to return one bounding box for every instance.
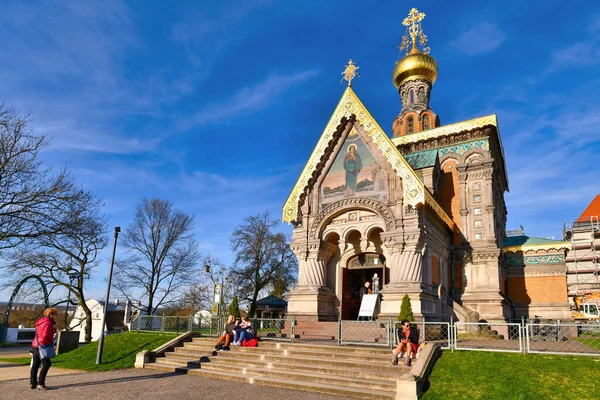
[0,104,78,250]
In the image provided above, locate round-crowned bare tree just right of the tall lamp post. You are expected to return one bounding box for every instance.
[115,198,199,315]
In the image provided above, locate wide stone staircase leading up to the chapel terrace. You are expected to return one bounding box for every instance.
[144,338,410,399]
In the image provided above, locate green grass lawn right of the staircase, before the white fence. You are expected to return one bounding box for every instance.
[423,350,600,400]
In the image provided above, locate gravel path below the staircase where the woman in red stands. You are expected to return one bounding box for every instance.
[0,368,341,400]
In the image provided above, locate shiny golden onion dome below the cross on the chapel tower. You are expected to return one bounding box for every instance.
[392,42,438,89]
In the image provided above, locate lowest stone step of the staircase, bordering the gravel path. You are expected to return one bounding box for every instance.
[188,368,395,399]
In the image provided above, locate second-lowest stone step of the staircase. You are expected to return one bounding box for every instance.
[201,362,396,392]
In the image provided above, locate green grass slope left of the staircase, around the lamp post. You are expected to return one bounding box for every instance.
[0,332,176,371]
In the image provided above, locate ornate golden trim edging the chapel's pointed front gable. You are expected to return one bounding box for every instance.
[283,86,454,233]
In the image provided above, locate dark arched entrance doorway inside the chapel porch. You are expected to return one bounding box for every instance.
[341,253,390,320]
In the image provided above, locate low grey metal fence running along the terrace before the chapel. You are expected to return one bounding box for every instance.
[131,315,600,356]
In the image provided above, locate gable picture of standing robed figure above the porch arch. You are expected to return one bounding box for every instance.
[319,127,392,210]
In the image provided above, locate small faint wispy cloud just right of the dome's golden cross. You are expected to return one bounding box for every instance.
[450,21,506,55]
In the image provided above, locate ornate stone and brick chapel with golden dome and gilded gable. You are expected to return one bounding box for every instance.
[283,9,568,321]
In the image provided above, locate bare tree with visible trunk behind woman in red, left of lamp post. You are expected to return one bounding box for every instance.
[5,190,107,342]
